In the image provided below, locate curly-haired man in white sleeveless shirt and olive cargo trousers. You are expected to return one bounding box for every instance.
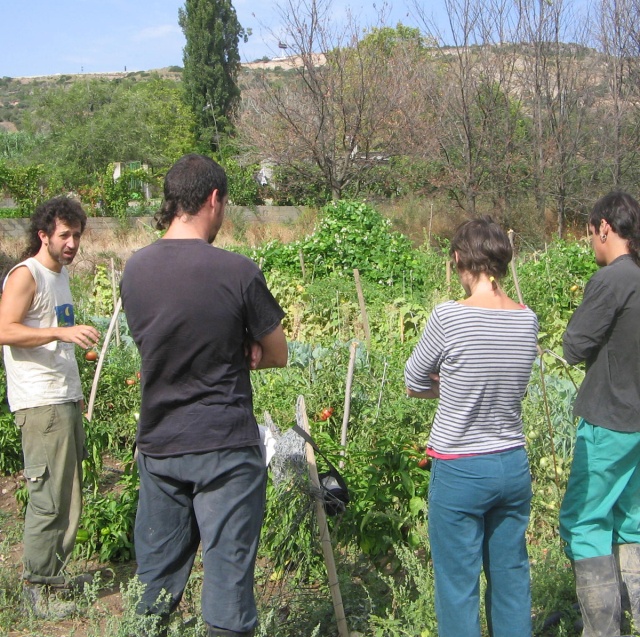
[0,197,100,618]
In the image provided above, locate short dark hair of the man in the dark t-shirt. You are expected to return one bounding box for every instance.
[155,153,227,230]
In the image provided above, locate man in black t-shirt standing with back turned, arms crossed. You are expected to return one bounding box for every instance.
[121,154,287,637]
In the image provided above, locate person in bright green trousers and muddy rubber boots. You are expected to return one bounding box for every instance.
[560,192,640,637]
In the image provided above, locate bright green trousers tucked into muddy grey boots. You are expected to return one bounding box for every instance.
[560,419,640,560]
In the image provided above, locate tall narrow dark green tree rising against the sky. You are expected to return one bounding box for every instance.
[178,0,247,150]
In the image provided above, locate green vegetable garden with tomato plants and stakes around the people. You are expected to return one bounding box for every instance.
[0,201,596,637]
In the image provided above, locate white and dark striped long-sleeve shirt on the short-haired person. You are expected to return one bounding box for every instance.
[405,301,538,454]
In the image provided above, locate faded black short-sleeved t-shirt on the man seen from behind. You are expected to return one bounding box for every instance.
[121,239,284,457]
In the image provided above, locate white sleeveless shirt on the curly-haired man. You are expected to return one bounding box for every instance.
[3,258,82,411]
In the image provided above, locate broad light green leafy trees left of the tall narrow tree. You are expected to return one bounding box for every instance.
[23,76,194,188]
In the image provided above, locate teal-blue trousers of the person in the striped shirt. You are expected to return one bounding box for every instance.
[428,448,532,637]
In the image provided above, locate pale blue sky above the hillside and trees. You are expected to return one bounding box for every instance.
[0,0,412,77]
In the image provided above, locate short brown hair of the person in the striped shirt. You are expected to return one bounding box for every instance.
[450,216,513,279]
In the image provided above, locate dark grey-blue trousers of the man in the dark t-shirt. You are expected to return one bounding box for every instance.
[135,447,266,633]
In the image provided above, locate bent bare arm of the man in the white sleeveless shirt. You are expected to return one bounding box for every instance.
[0,267,100,349]
